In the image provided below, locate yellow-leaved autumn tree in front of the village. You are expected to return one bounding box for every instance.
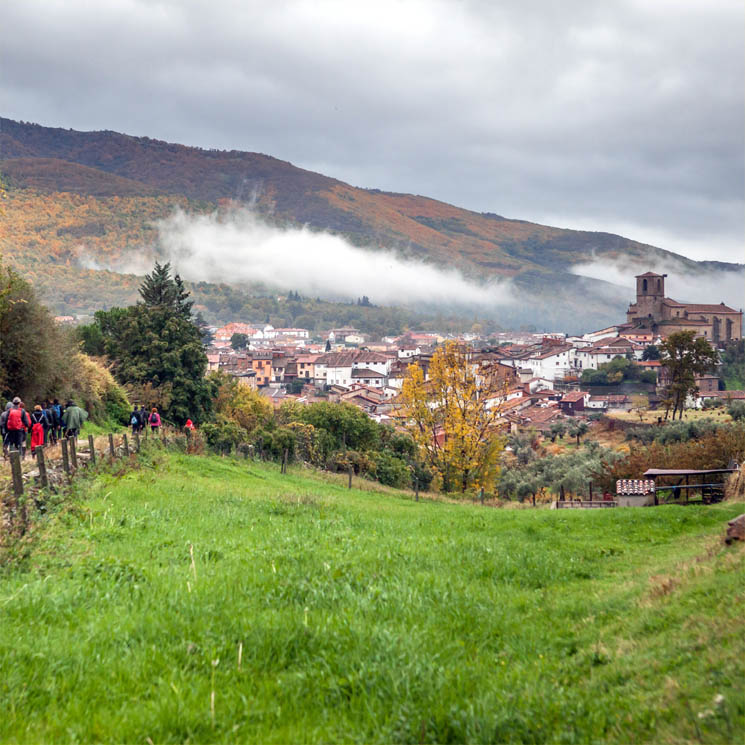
[401,342,506,493]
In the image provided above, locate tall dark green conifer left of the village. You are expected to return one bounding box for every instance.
[87,264,214,424]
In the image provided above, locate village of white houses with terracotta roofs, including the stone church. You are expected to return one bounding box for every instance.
[201,272,745,434]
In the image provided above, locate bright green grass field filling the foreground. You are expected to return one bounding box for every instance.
[0,455,745,743]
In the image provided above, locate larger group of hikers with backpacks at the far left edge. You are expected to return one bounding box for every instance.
[0,396,88,457]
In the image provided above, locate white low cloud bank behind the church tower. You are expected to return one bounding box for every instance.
[571,258,745,310]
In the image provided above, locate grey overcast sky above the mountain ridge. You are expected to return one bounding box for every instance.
[0,0,745,262]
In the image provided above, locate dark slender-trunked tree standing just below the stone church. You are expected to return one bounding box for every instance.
[660,331,719,419]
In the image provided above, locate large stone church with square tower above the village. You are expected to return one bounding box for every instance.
[626,272,742,343]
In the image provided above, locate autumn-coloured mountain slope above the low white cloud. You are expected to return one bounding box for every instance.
[0,118,734,326]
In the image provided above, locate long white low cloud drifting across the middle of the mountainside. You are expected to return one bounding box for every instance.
[153,210,514,307]
